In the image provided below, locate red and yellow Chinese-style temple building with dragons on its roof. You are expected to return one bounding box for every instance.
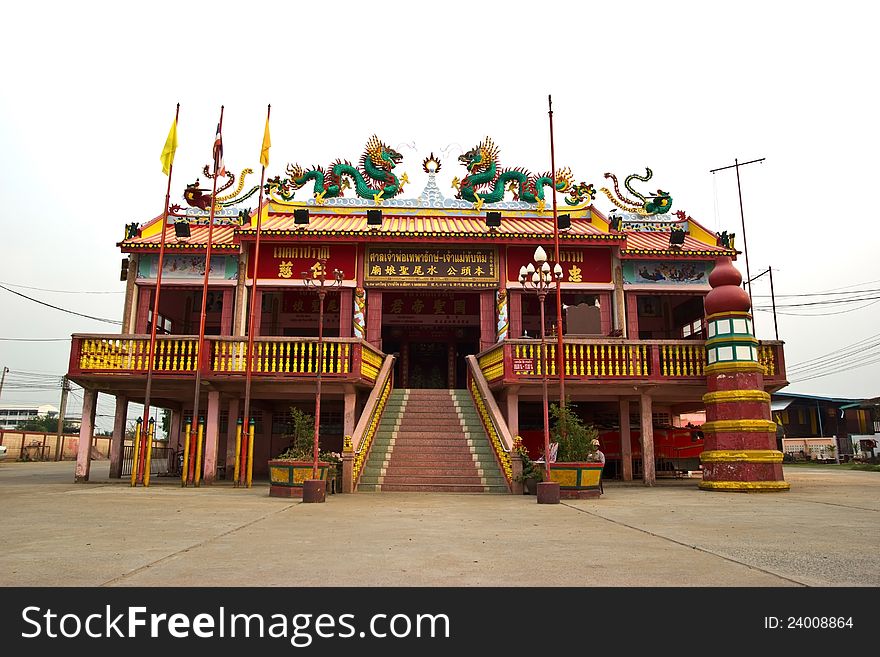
[68,138,787,492]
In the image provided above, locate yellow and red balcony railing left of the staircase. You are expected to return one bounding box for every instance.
[68,334,384,385]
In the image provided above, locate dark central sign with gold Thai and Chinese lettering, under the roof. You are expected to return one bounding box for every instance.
[364,246,498,288]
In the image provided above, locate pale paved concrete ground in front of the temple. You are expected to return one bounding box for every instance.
[0,461,880,587]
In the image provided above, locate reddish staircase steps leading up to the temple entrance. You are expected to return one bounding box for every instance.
[358,389,510,493]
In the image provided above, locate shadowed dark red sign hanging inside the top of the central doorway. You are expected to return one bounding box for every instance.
[382,291,480,326]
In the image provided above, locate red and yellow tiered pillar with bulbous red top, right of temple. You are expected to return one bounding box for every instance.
[700,257,789,493]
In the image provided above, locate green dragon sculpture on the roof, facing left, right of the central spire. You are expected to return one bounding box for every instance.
[452,137,574,210]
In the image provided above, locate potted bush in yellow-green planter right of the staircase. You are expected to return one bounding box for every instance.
[550,404,604,499]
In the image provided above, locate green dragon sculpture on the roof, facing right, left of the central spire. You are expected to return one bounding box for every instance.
[265,135,409,204]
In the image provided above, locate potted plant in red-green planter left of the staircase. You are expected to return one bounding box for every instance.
[269,406,332,497]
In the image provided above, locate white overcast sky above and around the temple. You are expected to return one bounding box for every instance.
[0,0,880,426]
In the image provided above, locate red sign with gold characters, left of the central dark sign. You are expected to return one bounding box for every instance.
[248,242,357,281]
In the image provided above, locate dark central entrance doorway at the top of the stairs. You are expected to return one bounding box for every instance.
[382,290,480,389]
